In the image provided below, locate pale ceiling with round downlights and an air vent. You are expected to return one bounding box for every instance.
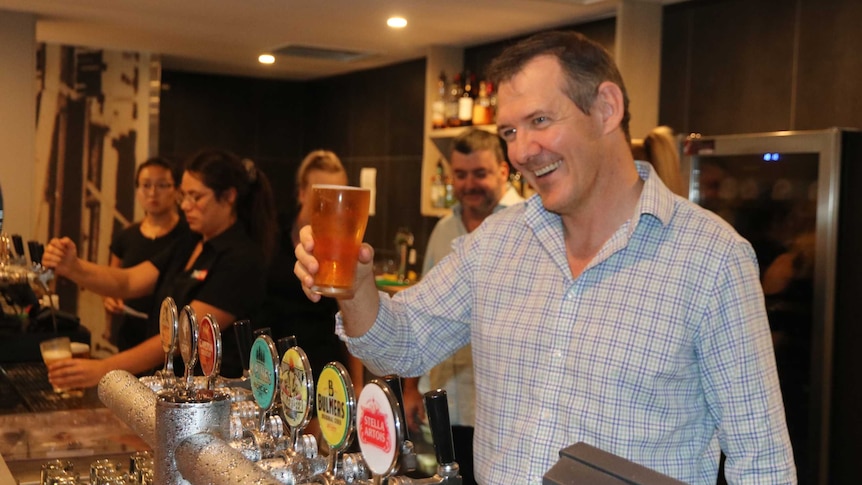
[0,0,682,80]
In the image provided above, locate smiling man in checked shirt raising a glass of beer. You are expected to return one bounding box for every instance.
[295,32,796,485]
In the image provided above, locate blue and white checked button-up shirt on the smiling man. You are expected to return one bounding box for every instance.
[338,162,796,485]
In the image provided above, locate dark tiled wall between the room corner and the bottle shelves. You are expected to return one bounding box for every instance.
[305,59,437,257]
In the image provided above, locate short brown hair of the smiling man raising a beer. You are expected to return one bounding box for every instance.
[488,31,631,140]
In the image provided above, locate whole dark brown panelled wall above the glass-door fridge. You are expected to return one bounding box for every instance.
[660,0,862,135]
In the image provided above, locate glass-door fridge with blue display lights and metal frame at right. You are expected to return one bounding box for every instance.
[682,129,862,484]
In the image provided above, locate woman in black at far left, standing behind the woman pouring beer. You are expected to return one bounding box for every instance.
[103,157,189,351]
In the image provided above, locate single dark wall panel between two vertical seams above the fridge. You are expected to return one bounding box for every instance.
[688,0,795,134]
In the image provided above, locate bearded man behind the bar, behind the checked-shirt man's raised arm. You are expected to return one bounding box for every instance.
[404,128,524,485]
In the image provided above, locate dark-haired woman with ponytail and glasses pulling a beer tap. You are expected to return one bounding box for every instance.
[42,149,275,388]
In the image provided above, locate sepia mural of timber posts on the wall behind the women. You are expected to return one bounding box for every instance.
[34,44,151,349]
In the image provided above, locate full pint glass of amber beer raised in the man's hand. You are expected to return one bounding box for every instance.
[311,185,371,298]
